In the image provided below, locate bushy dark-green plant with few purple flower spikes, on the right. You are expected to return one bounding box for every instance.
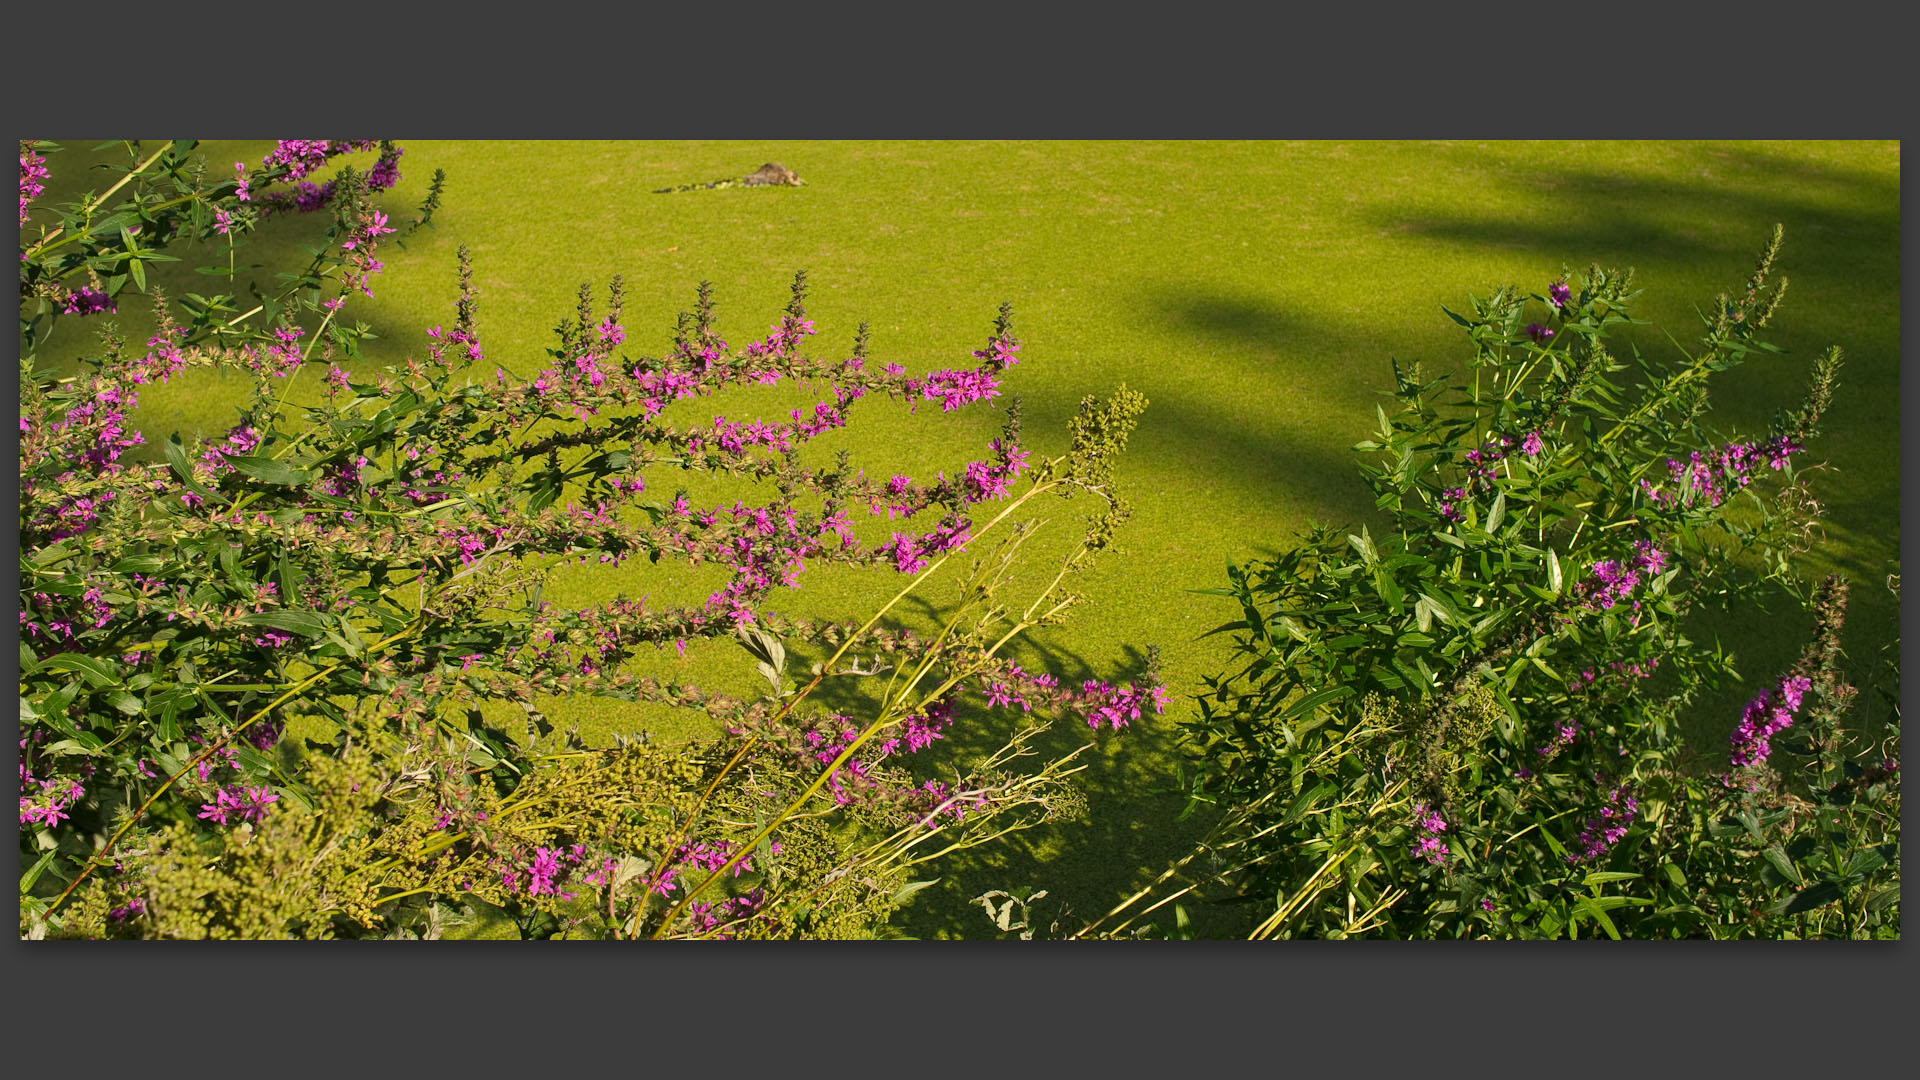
[1092,231,1899,938]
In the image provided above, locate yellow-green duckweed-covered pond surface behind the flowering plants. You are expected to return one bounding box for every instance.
[33,140,1899,936]
